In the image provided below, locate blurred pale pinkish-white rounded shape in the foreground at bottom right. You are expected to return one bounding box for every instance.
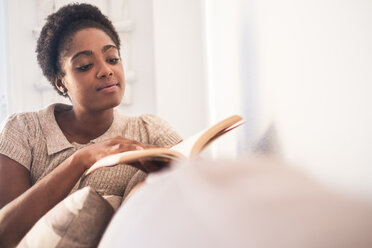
[99,158,372,248]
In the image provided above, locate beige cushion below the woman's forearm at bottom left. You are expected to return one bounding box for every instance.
[18,187,114,247]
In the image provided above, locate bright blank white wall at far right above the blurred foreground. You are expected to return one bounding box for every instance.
[250,0,372,195]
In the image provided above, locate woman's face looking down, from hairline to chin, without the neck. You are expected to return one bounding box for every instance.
[57,28,125,112]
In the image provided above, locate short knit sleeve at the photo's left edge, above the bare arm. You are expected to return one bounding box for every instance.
[0,114,32,170]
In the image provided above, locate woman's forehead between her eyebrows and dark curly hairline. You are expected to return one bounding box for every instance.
[66,28,115,56]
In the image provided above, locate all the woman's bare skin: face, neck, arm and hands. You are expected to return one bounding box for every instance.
[0,28,160,247]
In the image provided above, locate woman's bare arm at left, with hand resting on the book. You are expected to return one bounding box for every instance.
[0,137,150,247]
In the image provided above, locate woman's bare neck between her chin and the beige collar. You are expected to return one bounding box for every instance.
[56,108,114,144]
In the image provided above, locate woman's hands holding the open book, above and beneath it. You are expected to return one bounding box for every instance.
[75,136,169,173]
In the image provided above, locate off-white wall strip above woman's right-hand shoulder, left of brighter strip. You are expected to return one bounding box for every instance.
[153,0,208,137]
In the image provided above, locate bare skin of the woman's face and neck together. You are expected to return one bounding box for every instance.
[56,28,125,143]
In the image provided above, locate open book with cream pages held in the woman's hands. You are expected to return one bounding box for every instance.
[85,115,243,175]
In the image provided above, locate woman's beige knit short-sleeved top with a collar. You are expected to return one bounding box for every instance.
[0,104,181,195]
